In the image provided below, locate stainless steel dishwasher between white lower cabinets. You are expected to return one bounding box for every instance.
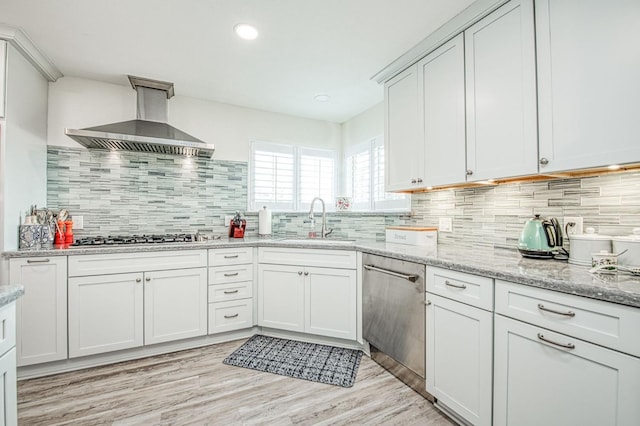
[362,253,433,400]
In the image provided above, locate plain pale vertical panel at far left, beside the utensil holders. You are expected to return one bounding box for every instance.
[0,45,47,251]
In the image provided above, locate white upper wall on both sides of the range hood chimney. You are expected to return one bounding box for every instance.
[48,77,341,161]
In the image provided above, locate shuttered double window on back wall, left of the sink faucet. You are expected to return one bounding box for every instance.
[249,141,336,211]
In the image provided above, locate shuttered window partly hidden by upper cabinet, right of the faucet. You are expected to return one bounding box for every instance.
[344,136,411,211]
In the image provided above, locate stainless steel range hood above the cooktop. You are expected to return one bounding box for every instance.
[64,75,214,158]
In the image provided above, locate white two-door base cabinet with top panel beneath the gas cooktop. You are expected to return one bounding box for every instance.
[69,250,208,358]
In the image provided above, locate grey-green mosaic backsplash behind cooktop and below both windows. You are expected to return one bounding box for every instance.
[47,146,410,240]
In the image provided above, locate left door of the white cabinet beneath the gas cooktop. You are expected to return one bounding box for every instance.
[69,273,143,358]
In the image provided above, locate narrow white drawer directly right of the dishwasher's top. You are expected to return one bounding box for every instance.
[426,266,493,311]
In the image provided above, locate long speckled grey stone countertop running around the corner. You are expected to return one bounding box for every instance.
[3,237,640,308]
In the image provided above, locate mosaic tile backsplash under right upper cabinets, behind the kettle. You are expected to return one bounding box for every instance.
[412,172,640,248]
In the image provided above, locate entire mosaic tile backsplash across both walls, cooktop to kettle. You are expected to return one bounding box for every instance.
[47,146,640,248]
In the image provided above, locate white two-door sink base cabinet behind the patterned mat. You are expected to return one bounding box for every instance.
[258,247,358,340]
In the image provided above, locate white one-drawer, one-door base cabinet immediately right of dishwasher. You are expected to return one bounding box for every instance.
[426,266,493,426]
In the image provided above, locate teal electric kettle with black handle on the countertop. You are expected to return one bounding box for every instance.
[518,214,562,259]
